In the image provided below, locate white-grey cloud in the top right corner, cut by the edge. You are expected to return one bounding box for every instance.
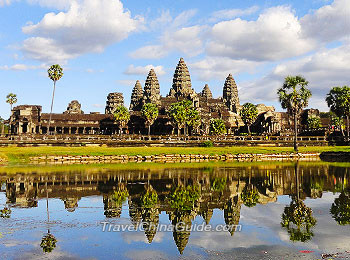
[300,0,350,42]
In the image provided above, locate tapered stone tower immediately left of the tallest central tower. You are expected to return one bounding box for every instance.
[142,69,160,105]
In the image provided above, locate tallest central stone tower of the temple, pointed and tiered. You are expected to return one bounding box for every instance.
[168,58,195,98]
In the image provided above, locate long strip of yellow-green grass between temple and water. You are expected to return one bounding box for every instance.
[0,146,350,163]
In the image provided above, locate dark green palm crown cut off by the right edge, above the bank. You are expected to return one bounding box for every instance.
[326,86,350,118]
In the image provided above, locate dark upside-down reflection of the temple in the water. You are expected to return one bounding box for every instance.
[0,163,349,253]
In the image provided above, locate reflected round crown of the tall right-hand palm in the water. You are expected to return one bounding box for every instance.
[281,200,316,242]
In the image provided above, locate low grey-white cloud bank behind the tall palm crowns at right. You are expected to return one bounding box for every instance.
[241,44,350,111]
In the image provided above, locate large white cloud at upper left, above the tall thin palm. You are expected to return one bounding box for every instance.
[22,0,143,62]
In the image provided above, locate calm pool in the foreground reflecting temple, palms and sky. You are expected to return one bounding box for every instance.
[0,162,350,259]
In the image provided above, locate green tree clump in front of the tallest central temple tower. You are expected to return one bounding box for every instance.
[168,100,200,134]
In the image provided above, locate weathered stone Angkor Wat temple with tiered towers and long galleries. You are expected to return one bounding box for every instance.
[10,58,318,135]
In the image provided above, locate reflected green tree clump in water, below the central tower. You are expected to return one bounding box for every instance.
[169,185,200,211]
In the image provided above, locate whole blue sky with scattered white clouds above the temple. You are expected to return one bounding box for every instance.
[0,0,350,118]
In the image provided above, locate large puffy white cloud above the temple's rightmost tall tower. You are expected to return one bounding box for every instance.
[207,6,316,61]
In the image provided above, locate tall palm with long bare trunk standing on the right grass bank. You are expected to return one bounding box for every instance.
[277,76,312,152]
